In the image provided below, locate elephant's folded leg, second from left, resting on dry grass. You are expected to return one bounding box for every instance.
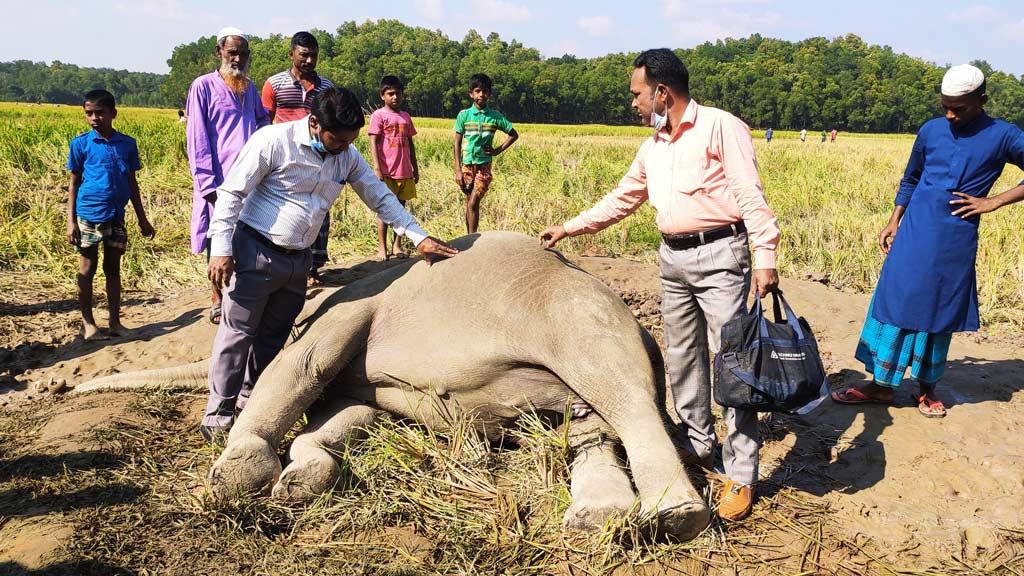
[272,390,381,502]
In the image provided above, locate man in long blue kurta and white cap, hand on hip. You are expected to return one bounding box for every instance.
[831,65,1024,417]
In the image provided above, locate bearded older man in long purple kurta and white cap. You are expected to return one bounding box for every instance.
[185,28,270,324]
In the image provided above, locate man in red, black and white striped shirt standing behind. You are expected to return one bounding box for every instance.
[263,32,334,285]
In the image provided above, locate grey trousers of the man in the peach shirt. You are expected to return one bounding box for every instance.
[659,234,759,484]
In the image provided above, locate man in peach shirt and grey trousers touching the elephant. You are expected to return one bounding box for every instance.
[541,48,779,521]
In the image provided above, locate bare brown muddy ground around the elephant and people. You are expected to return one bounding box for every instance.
[0,253,1024,574]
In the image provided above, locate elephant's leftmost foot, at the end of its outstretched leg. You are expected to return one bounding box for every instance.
[210,436,281,501]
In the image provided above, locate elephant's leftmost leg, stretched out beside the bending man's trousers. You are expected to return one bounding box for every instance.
[210,299,374,499]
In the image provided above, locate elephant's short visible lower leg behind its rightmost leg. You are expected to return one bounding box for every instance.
[562,414,637,530]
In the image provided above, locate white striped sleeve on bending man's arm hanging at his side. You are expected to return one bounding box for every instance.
[209,132,276,256]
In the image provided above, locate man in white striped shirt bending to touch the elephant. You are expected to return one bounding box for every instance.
[200,88,458,441]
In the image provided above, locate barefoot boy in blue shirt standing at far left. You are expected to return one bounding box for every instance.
[68,90,156,340]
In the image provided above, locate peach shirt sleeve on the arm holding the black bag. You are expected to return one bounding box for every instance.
[716,117,781,270]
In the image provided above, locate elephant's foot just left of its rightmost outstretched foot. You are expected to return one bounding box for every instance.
[562,443,636,530]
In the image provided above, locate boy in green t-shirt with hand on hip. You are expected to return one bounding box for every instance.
[455,74,519,234]
